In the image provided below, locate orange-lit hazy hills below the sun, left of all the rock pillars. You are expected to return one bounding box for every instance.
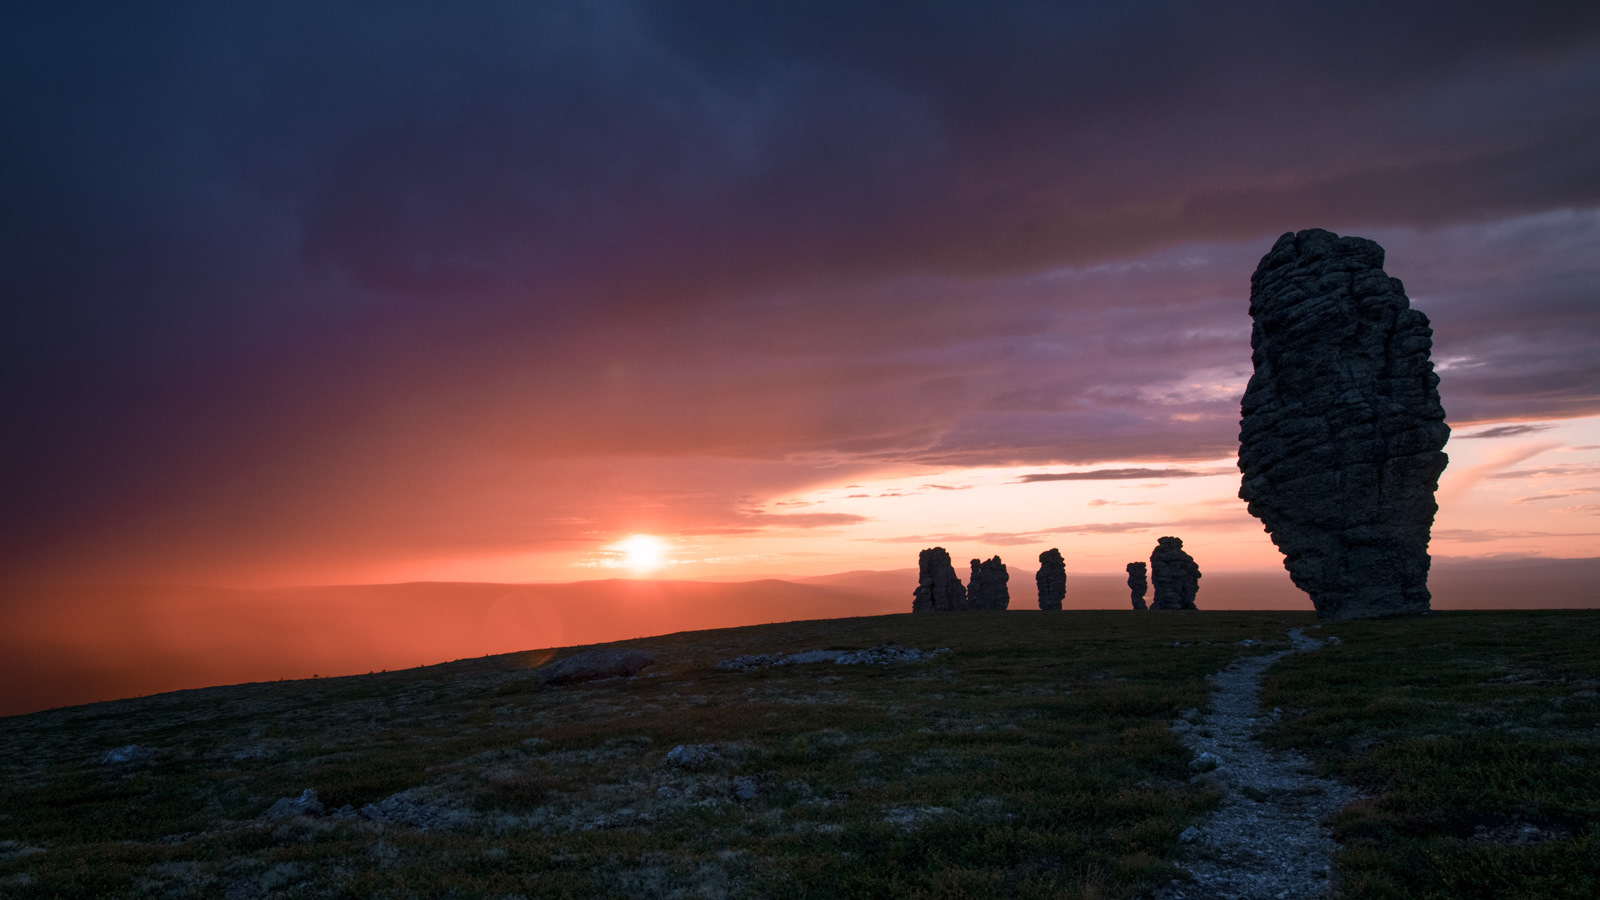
[0,577,915,714]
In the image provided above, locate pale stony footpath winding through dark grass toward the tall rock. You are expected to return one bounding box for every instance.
[1160,629,1357,900]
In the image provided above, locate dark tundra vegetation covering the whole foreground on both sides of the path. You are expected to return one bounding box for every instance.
[0,612,1600,898]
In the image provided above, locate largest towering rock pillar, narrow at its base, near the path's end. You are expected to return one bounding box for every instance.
[1238,229,1450,620]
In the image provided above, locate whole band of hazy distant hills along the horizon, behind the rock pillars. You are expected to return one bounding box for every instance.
[0,559,1600,714]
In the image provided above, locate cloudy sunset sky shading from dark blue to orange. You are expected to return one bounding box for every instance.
[0,0,1600,593]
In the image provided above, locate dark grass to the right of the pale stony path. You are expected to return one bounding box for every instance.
[1262,610,1600,900]
